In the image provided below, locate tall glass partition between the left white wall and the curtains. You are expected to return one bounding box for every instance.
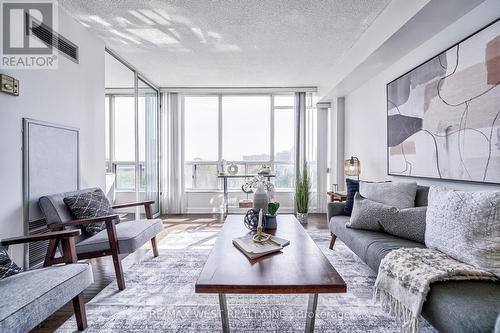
[104,51,160,218]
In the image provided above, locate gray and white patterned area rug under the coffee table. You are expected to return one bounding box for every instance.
[58,224,434,332]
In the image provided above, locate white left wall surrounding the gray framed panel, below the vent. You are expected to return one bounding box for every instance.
[0,9,105,264]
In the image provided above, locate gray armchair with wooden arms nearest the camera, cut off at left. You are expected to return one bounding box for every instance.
[0,230,93,332]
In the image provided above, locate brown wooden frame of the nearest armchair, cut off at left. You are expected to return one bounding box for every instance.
[0,230,87,331]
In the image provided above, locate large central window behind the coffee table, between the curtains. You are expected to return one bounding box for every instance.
[184,94,294,191]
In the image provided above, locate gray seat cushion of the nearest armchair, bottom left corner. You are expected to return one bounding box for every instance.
[0,263,93,332]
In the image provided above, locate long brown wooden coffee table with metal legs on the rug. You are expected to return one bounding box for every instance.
[195,215,347,332]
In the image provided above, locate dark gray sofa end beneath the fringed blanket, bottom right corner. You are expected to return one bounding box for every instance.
[422,281,500,333]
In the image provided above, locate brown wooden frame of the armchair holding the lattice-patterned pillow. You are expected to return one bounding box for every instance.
[44,201,158,290]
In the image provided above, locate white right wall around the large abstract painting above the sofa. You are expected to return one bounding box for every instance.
[345,0,500,189]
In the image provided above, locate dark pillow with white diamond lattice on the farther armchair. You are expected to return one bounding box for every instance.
[63,189,114,236]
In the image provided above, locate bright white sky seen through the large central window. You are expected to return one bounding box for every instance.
[184,95,294,161]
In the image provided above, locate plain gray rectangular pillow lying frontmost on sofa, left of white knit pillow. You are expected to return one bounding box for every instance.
[347,193,427,243]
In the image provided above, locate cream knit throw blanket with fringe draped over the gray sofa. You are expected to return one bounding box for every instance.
[374,248,497,333]
